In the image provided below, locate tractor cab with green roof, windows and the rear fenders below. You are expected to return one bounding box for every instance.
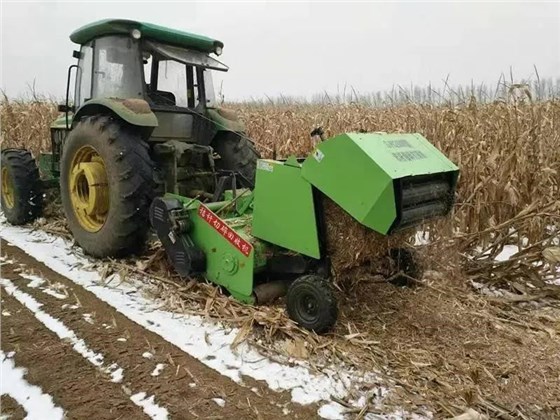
[55,19,244,145]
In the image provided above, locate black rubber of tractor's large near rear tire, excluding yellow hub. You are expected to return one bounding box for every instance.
[60,115,157,257]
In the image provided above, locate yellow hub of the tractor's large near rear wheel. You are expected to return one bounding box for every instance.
[69,146,109,232]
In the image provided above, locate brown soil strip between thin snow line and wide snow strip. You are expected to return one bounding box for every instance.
[2,240,317,419]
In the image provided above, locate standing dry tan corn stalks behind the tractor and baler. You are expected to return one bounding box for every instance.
[1,97,560,240]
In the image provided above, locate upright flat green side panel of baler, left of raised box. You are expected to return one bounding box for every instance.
[252,159,321,259]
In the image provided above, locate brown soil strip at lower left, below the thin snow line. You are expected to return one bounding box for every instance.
[1,292,145,419]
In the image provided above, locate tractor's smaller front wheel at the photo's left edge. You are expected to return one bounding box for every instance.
[0,149,43,225]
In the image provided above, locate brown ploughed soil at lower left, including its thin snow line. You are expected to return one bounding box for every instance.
[1,240,317,419]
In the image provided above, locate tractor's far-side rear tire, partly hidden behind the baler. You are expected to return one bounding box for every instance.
[212,132,260,188]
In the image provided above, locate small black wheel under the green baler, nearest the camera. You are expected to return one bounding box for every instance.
[286,275,338,334]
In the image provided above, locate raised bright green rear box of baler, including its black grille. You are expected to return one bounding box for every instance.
[302,133,459,234]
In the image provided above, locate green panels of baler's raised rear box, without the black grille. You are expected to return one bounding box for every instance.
[302,133,458,234]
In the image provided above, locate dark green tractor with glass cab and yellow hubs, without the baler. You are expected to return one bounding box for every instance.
[2,20,259,257]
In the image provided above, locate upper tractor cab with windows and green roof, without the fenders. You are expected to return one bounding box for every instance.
[70,21,228,110]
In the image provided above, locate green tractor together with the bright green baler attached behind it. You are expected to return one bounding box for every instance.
[2,20,459,333]
